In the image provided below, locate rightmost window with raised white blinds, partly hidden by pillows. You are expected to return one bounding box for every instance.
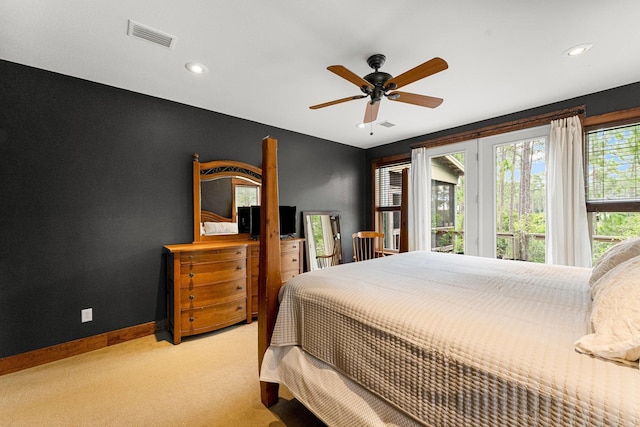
[585,117,640,263]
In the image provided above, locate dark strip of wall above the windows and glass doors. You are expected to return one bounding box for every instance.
[365,82,640,228]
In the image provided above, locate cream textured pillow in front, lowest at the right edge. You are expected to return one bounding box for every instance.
[575,256,640,366]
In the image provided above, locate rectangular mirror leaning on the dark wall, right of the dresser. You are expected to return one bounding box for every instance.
[302,211,343,270]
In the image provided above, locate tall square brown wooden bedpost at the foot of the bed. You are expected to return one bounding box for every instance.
[258,137,282,407]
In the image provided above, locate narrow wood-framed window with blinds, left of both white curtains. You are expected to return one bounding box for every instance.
[374,156,411,252]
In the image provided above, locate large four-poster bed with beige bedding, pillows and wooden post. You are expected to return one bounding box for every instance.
[258,138,640,426]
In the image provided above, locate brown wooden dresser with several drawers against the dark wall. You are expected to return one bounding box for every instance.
[164,239,304,344]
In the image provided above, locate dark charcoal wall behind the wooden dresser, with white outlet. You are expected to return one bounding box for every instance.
[0,61,367,357]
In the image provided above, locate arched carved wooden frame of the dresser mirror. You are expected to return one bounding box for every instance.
[193,153,262,243]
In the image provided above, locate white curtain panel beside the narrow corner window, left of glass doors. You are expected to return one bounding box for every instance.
[408,147,431,251]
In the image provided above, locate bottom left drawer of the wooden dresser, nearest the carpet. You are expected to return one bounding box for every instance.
[180,298,247,335]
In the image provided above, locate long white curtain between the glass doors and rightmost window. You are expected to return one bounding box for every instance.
[545,116,591,267]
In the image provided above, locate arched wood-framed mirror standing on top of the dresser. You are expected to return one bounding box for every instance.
[193,153,262,242]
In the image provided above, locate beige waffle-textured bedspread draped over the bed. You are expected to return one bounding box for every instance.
[261,252,640,426]
